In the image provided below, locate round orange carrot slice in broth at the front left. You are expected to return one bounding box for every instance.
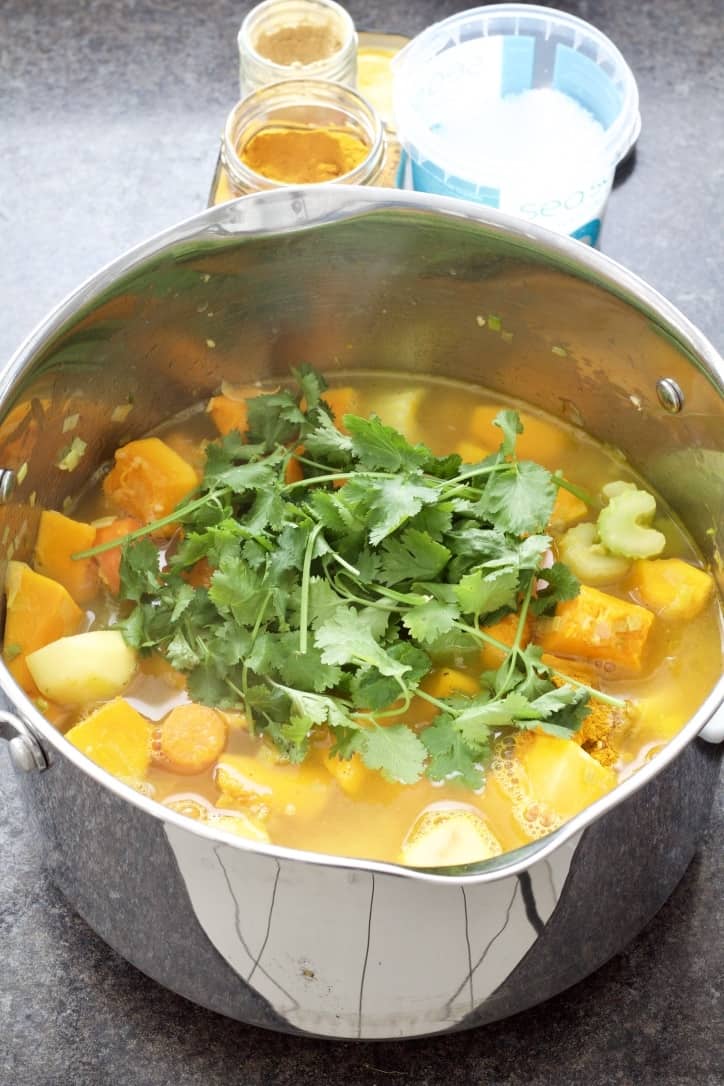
[154,705,228,774]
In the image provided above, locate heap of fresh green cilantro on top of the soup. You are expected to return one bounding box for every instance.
[96,366,607,790]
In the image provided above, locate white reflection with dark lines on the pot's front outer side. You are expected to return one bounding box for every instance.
[166,825,577,1037]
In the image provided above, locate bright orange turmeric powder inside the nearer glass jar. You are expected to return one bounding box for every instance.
[238,127,369,185]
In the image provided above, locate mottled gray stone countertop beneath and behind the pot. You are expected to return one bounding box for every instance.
[0,0,724,1086]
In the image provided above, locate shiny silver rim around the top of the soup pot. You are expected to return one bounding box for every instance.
[0,185,724,886]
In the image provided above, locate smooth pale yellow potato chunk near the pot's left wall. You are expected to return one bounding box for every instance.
[27,630,136,705]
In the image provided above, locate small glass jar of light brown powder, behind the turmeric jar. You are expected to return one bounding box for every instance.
[238,0,357,98]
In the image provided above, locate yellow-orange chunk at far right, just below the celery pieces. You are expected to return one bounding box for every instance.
[628,558,714,621]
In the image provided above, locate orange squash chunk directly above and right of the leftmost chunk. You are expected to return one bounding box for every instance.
[33,509,98,604]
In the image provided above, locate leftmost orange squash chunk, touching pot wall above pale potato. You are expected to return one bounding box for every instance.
[3,561,85,695]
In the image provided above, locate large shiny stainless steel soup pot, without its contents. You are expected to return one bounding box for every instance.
[0,186,724,1038]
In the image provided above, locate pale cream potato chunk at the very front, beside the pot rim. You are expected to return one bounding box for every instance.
[401,805,503,868]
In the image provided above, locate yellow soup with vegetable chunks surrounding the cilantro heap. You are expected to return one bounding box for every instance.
[5,374,722,867]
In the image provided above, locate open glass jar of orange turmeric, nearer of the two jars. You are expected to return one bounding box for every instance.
[208,79,385,205]
